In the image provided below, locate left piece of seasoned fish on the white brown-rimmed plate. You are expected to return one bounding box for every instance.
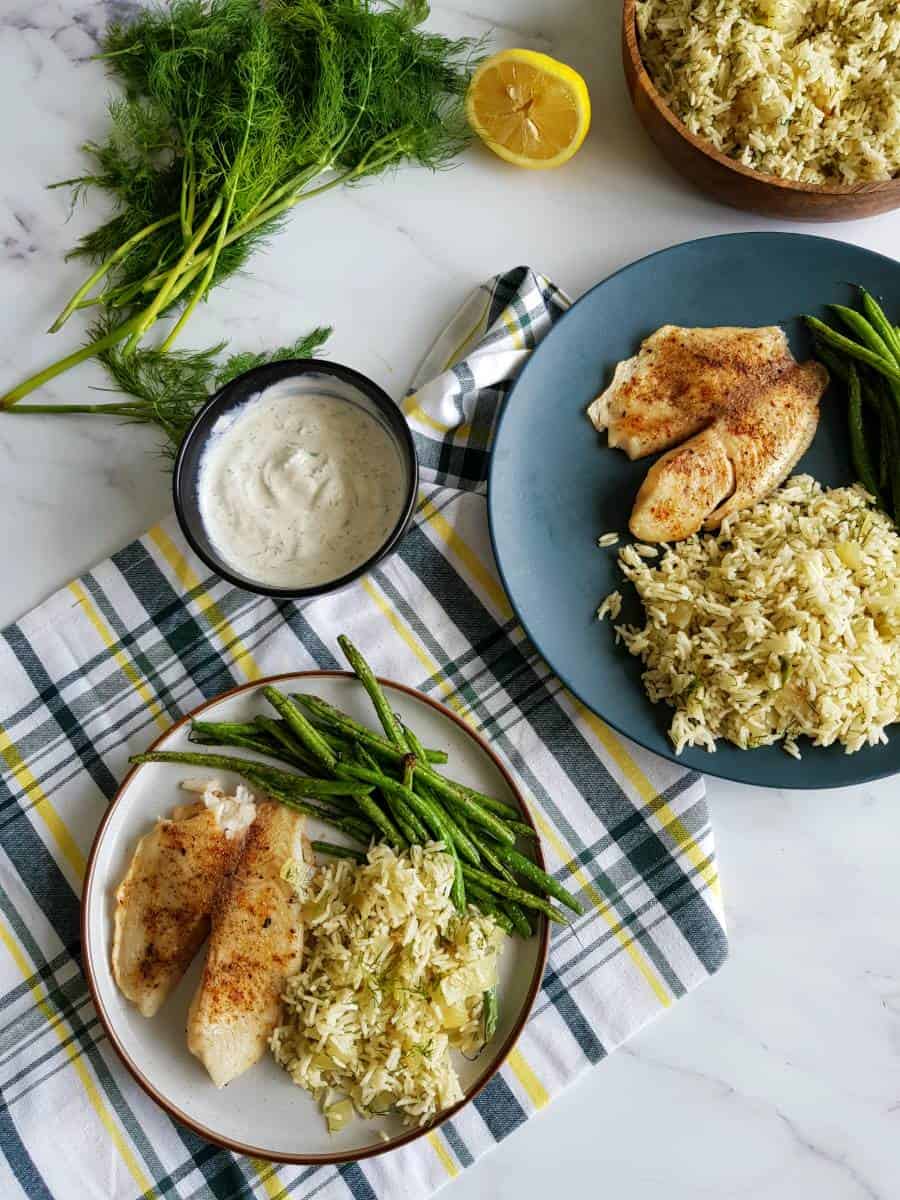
[113,803,242,1016]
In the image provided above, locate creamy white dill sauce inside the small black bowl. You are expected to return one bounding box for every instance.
[198,379,406,588]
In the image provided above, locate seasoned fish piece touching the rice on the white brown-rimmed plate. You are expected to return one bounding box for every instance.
[187,800,311,1087]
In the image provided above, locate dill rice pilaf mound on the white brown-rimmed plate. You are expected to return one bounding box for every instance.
[271,844,505,1130]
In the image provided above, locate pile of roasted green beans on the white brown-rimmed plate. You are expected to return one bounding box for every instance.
[131,635,583,937]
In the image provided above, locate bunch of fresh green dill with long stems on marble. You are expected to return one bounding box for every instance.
[0,0,478,417]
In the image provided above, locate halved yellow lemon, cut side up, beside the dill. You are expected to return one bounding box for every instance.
[466,50,590,169]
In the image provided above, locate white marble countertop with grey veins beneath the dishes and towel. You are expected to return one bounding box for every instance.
[0,0,900,1200]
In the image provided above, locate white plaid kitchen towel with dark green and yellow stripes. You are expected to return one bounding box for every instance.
[0,269,726,1200]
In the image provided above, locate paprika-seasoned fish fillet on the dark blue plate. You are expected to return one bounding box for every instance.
[588,325,828,541]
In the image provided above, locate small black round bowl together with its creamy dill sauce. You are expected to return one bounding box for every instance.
[173,359,419,598]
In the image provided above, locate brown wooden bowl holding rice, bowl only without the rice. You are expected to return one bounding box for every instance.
[622,0,900,221]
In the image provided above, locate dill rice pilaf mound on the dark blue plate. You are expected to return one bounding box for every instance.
[616,475,900,757]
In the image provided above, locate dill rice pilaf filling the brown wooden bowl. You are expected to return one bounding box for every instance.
[636,0,900,184]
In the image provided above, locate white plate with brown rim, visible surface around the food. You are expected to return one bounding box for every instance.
[82,671,550,1164]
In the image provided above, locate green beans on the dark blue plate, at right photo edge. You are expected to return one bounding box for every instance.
[804,288,900,524]
